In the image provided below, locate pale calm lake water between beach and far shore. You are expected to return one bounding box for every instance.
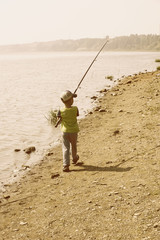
[0,52,160,186]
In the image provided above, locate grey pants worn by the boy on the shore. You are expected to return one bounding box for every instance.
[62,132,78,166]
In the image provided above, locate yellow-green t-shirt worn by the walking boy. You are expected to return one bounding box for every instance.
[60,106,79,133]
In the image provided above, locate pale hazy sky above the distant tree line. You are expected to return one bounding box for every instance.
[0,0,160,45]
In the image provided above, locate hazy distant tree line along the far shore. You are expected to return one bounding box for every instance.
[0,34,160,52]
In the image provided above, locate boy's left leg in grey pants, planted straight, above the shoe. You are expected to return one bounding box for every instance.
[62,133,70,166]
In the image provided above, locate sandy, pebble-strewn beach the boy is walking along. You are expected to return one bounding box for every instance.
[0,71,160,240]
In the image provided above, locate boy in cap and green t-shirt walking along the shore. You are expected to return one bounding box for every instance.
[55,90,79,172]
